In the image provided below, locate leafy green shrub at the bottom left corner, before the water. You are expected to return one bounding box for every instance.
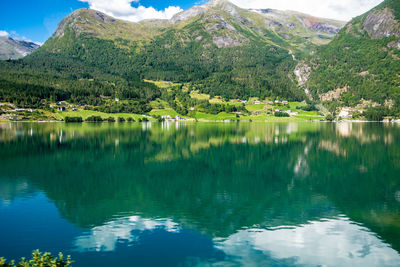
[0,250,72,267]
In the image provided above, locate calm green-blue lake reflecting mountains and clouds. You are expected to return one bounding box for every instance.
[0,122,400,267]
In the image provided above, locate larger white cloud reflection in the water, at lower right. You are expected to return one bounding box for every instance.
[216,217,400,266]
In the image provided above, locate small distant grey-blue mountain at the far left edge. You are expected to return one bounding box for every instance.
[0,36,39,60]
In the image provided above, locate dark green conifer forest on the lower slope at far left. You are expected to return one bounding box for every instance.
[0,31,161,113]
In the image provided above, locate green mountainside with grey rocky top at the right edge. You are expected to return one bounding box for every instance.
[306,0,400,110]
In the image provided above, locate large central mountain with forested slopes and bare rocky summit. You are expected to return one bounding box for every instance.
[0,1,344,109]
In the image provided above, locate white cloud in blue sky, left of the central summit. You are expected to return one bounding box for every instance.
[80,0,183,22]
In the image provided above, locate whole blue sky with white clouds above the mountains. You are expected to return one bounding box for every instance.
[0,0,383,44]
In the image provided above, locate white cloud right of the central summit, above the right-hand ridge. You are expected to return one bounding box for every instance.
[231,0,383,21]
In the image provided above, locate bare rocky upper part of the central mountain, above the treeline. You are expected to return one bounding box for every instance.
[46,0,345,54]
